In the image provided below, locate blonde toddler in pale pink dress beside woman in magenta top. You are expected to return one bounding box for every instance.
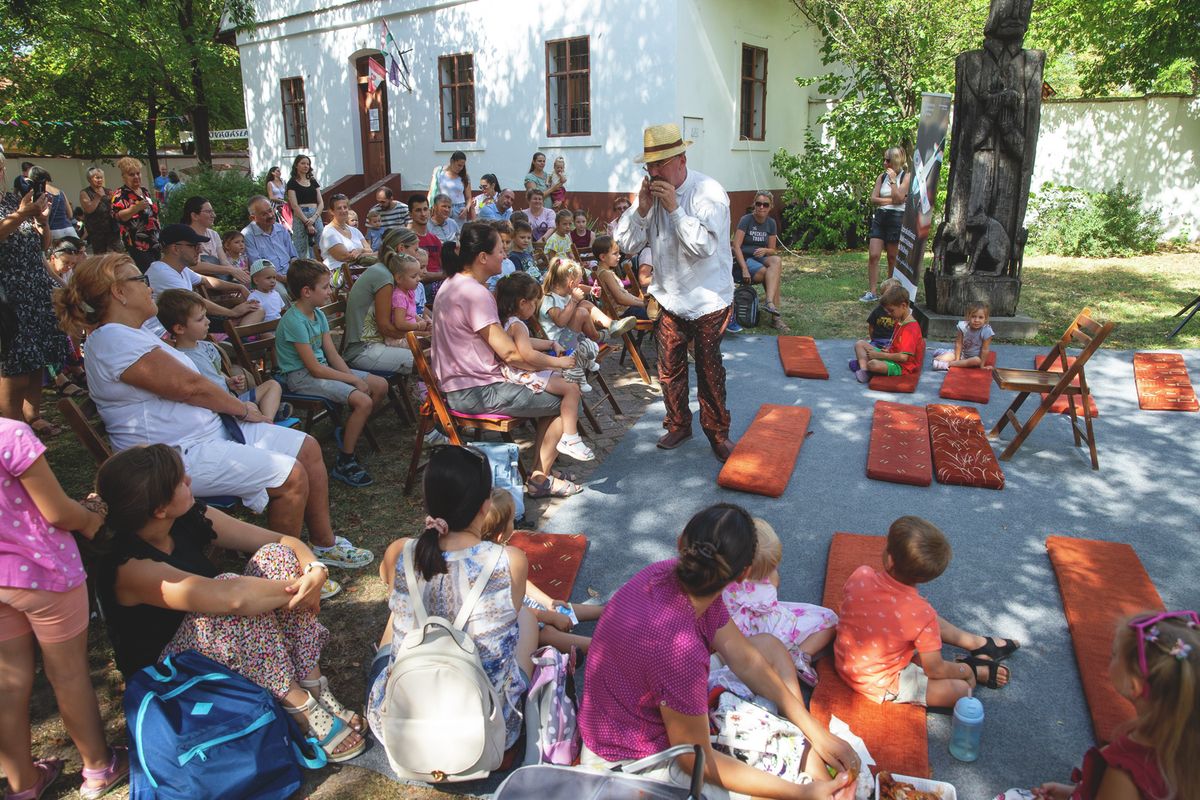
[725,517,838,686]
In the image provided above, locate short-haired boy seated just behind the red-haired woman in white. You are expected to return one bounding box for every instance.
[157,289,292,422]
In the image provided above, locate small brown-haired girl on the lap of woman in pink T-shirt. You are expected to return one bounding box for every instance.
[496,272,595,461]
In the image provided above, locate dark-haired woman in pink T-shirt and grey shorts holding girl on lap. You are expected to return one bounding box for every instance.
[432,222,583,498]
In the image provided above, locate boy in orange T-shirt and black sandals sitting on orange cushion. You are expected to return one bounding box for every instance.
[834,515,1020,708]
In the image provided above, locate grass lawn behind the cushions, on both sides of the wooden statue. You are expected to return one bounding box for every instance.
[755,251,1200,349]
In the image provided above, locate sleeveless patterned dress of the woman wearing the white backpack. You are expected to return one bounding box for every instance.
[367,542,527,748]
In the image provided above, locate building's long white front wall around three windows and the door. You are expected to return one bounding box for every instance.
[239,0,677,192]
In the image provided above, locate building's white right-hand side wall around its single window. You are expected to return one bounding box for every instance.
[678,0,823,192]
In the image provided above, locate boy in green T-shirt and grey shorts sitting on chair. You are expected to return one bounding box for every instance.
[275,258,388,487]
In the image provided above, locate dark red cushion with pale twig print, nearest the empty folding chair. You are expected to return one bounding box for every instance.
[925,403,1004,489]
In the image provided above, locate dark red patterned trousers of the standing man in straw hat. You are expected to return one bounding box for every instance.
[654,307,732,439]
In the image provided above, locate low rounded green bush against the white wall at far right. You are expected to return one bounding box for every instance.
[1027,182,1164,258]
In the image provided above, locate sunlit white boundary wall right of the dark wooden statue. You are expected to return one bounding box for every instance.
[1032,95,1200,241]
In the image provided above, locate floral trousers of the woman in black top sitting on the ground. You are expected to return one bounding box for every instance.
[162,542,329,698]
